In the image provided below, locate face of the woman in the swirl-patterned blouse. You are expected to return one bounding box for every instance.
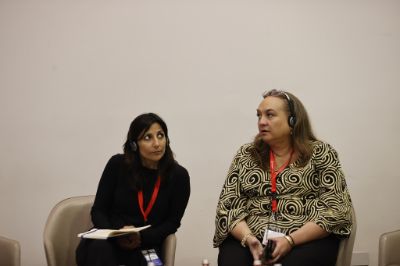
[257,96,291,144]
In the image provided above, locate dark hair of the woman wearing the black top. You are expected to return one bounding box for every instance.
[124,113,175,189]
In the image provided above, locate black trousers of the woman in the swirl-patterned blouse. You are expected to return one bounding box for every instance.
[218,236,340,266]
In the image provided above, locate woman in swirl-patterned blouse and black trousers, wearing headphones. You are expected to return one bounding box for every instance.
[214,90,352,266]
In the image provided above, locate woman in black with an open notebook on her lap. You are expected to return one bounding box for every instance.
[76,113,190,266]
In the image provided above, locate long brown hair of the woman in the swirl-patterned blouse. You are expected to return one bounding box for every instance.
[254,89,317,169]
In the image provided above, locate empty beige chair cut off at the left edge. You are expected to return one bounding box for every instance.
[0,236,21,266]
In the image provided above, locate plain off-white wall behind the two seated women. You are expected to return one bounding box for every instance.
[0,0,400,266]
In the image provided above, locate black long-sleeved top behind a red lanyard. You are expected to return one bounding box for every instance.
[91,154,190,247]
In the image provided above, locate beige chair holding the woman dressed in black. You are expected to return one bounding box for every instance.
[43,196,176,266]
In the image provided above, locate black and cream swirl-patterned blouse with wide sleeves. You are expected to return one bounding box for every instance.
[213,141,352,247]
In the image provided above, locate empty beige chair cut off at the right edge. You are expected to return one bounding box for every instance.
[379,230,400,266]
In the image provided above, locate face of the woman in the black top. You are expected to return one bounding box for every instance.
[137,123,167,169]
